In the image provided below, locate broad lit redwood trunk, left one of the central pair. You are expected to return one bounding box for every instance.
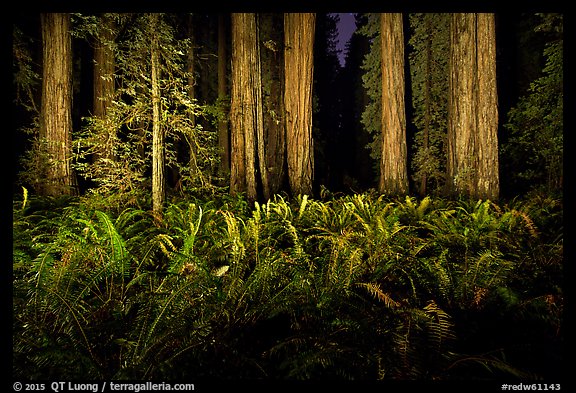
[230,14,268,201]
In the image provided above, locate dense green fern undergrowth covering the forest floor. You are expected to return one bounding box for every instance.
[13,193,563,380]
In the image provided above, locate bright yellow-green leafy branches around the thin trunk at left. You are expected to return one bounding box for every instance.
[74,14,218,204]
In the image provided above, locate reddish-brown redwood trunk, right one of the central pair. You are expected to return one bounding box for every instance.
[284,13,316,195]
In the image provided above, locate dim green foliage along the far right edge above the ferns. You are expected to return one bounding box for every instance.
[504,14,564,192]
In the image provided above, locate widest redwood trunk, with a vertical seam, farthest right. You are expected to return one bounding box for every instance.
[447,14,499,199]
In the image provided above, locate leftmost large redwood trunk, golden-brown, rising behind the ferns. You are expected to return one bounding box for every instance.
[39,13,78,196]
